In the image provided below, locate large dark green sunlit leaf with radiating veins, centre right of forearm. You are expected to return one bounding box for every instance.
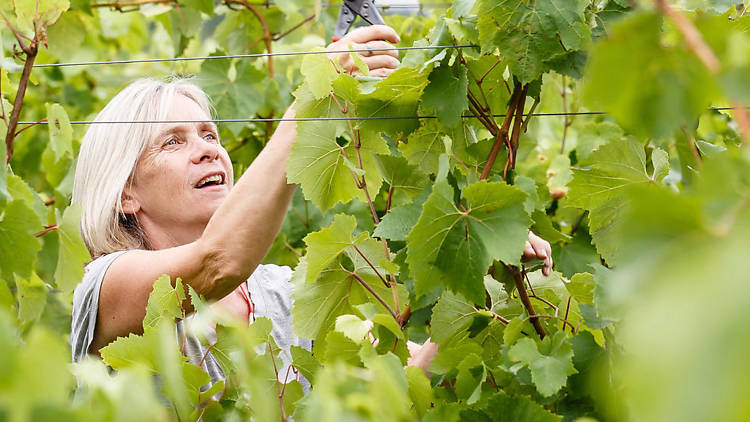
[406,181,531,303]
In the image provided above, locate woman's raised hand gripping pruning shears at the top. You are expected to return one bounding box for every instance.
[327,25,401,77]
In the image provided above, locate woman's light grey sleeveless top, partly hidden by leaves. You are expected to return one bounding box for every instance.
[70,251,312,391]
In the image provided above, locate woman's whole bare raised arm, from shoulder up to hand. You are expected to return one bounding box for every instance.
[89,26,398,352]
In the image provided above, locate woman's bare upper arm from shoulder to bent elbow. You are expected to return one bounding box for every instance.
[89,241,242,352]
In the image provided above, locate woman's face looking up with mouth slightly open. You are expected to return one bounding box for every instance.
[123,95,234,249]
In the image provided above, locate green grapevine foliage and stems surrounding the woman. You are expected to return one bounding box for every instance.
[0,0,750,421]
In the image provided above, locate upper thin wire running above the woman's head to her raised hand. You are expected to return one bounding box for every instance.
[33,44,479,68]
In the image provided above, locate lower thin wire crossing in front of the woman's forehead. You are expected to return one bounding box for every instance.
[18,107,750,125]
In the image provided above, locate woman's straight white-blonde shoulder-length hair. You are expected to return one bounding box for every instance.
[73,79,212,258]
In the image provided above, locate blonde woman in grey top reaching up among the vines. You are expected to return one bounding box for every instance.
[71,26,550,390]
